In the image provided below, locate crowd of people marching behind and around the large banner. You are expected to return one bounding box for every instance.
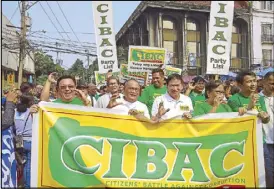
[2,68,274,187]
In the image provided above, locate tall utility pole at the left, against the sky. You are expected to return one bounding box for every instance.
[18,1,27,88]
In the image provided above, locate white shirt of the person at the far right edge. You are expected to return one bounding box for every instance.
[260,92,274,144]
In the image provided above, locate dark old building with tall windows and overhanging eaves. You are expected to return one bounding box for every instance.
[116,1,251,75]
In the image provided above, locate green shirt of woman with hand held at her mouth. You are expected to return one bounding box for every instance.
[194,102,233,116]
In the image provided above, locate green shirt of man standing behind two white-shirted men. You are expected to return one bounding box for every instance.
[138,85,167,116]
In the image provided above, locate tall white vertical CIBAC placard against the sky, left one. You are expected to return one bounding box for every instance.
[92,1,118,73]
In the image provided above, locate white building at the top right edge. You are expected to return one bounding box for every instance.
[252,1,274,68]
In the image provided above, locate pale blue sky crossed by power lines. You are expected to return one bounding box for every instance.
[2,1,140,68]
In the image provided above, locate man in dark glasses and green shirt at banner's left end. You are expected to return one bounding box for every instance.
[40,73,90,106]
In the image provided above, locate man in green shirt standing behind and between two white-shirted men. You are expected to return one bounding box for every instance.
[138,68,167,116]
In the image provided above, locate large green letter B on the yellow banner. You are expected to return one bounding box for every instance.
[132,141,167,179]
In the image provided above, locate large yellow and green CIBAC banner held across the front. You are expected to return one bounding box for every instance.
[31,103,264,188]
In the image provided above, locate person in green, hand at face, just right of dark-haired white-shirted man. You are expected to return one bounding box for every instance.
[185,76,206,108]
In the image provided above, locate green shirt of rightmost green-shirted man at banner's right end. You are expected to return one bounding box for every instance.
[228,93,266,112]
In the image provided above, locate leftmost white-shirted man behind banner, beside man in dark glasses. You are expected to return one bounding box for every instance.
[95,76,123,108]
